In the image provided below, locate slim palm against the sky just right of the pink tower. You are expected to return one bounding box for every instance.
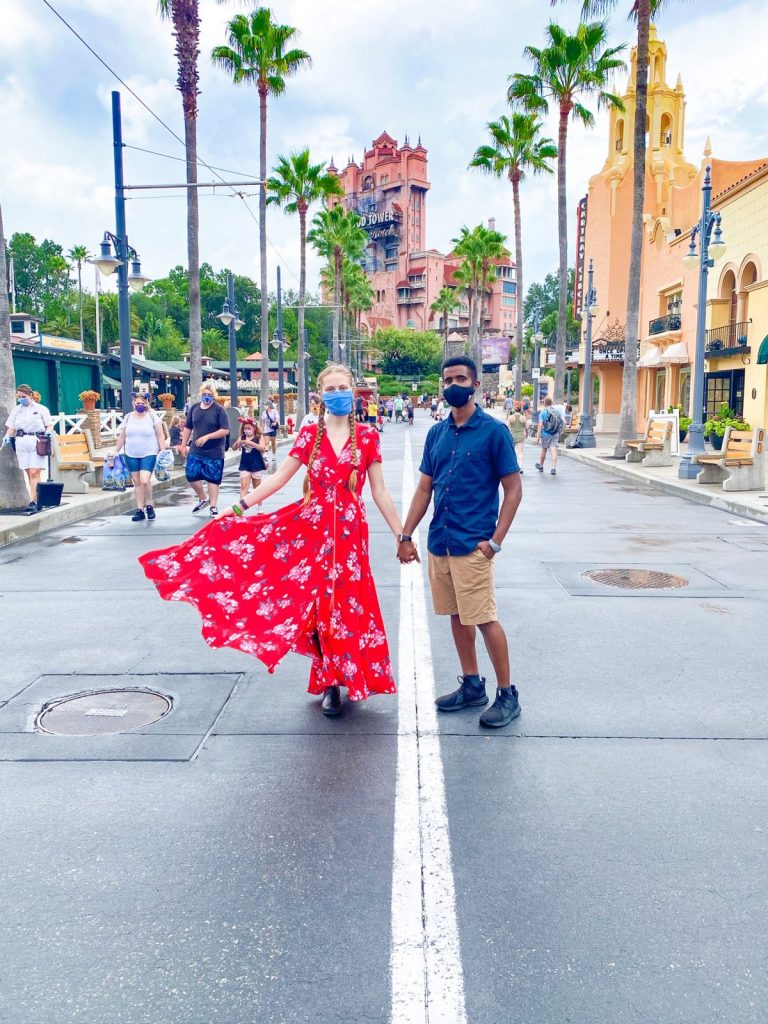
[469,111,557,400]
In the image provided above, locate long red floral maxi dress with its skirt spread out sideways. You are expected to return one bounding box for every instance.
[139,425,395,700]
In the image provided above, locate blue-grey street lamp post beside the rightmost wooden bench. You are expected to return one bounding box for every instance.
[677,161,725,480]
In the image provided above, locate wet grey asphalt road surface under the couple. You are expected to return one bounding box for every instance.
[0,414,768,1024]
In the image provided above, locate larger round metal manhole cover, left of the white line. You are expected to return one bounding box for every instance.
[36,689,171,736]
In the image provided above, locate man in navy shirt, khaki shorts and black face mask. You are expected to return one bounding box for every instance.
[397,355,522,729]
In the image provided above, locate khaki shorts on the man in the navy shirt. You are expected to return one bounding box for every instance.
[429,549,497,626]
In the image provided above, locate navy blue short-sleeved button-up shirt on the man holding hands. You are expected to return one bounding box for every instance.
[419,406,520,555]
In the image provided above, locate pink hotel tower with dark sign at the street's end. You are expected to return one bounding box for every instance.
[328,132,517,337]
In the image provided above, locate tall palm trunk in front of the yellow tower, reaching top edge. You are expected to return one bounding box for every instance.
[613,0,650,456]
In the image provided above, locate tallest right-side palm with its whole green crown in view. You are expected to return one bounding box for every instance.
[507,22,625,399]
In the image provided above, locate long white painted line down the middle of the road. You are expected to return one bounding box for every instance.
[390,434,467,1024]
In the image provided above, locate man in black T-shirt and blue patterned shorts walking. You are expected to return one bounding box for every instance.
[181,381,229,517]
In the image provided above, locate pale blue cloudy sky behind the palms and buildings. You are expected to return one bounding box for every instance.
[0,0,768,303]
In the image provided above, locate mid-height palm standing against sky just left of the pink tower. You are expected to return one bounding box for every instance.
[266,146,344,423]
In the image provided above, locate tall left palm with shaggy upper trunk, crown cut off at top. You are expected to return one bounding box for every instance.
[158,0,203,394]
